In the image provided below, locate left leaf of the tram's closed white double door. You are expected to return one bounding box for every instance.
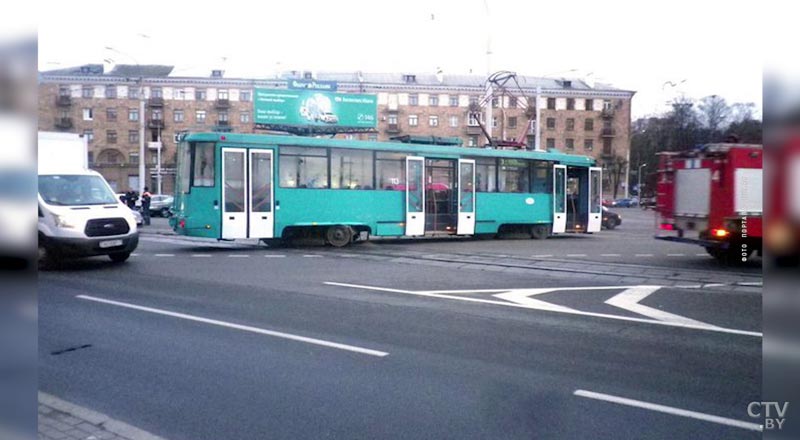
[222,148,247,239]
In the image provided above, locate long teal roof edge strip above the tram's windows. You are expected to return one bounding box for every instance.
[184,133,595,167]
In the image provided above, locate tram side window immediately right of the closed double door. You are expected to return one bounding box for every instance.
[280,147,328,188]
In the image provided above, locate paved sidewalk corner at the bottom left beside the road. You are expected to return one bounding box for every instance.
[38,392,164,440]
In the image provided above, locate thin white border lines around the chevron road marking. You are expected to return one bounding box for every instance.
[323,281,764,338]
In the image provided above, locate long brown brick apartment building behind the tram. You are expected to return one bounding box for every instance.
[39,64,634,193]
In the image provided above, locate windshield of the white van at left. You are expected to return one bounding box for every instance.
[39,175,118,206]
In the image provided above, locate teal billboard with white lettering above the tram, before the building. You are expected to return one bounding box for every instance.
[253,88,378,128]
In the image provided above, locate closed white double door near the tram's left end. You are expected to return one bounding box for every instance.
[222,148,275,239]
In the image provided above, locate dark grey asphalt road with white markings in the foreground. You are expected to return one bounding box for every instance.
[39,218,761,440]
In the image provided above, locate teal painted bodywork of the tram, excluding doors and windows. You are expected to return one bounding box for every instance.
[170,133,594,239]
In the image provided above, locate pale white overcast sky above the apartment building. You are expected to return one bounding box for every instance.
[38,0,765,118]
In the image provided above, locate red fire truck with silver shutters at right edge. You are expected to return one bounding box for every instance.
[656,144,764,262]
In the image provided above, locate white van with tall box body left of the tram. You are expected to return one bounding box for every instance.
[38,132,139,266]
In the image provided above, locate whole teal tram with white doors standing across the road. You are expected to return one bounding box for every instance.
[170,133,602,247]
